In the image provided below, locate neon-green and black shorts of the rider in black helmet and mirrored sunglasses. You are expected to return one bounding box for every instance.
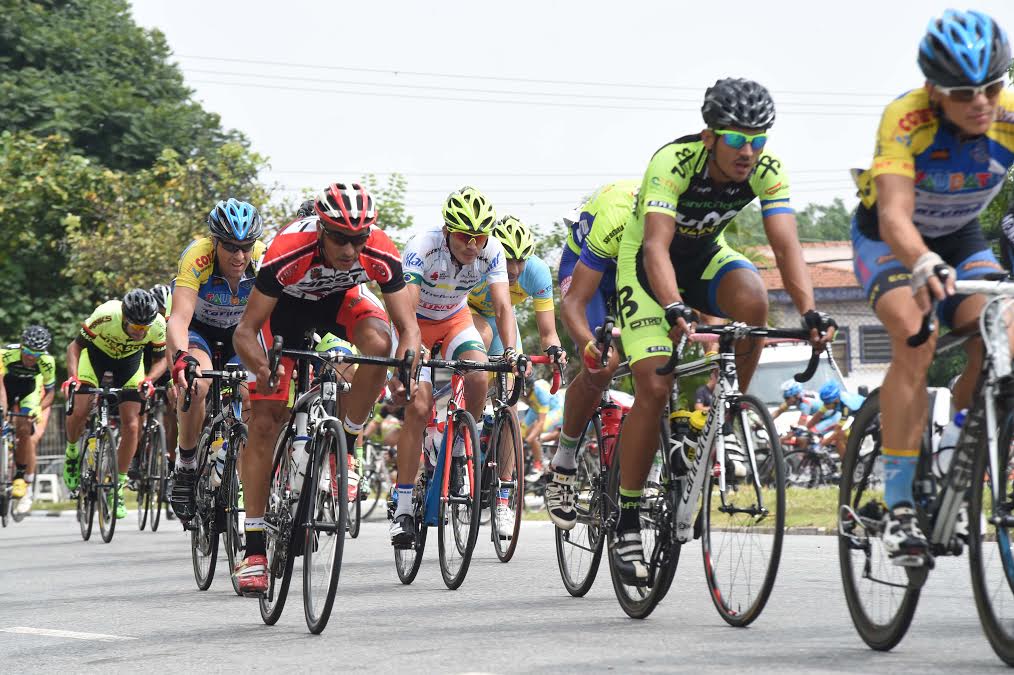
[617,238,761,363]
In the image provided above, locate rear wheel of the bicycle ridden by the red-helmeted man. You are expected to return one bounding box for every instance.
[260,430,299,625]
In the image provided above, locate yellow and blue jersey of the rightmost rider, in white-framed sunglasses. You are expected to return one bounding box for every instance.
[853,87,1014,239]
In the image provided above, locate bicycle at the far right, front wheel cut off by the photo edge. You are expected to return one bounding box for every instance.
[839,279,1014,666]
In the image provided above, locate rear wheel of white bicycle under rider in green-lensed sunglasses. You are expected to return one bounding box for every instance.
[603,423,679,618]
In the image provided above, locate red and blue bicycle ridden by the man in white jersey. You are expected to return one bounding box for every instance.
[387,346,529,590]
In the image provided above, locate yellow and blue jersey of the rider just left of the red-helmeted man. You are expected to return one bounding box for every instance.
[172,237,266,332]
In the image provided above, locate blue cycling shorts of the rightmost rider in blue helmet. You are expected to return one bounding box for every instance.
[852,216,1003,327]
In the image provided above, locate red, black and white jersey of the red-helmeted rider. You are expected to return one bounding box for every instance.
[256,216,405,300]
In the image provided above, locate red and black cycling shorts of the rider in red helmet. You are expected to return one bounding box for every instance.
[250,285,388,400]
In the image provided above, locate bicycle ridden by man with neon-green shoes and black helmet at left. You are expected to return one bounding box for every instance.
[67,384,131,543]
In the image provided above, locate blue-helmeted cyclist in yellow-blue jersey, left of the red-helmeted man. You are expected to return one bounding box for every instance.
[166,198,265,524]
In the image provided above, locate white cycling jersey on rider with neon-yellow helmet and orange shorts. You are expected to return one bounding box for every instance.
[402,229,507,320]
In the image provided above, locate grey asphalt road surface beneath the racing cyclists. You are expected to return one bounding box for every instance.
[0,514,1003,673]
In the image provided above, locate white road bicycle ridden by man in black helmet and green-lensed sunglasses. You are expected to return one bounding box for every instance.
[606,323,829,626]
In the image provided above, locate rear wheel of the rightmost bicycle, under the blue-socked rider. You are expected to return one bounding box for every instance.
[838,390,926,651]
